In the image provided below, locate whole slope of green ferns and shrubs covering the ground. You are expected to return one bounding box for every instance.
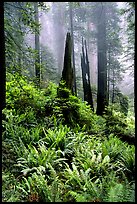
[2,73,135,202]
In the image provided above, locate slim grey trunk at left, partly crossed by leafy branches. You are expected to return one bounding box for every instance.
[34,2,40,86]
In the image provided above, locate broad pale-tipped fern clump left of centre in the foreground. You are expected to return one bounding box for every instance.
[15,143,65,177]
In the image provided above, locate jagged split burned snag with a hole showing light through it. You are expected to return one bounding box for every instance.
[81,39,94,111]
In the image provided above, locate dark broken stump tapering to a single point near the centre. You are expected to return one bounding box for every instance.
[61,33,73,93]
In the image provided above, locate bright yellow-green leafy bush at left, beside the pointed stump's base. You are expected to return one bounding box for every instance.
[6,73,56,123]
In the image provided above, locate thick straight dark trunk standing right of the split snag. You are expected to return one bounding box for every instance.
[97,3,107,115]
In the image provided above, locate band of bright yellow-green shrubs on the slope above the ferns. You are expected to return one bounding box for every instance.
[6,74,104,133]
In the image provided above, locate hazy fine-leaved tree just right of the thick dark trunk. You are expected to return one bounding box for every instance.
[106,2,124,103]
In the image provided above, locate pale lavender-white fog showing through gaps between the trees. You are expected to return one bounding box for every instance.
[25,2,134,99]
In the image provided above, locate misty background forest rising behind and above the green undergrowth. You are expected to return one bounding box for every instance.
[4,2,134,115]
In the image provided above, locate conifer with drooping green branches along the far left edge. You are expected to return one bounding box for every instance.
[4,2,24,73]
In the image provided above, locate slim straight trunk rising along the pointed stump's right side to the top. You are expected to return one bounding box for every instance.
[69,2,77,95]
